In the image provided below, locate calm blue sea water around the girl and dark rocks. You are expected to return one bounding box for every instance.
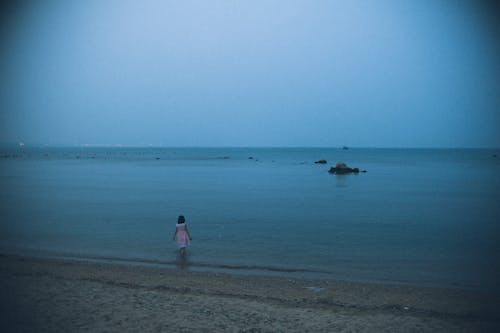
[0,147,500,290]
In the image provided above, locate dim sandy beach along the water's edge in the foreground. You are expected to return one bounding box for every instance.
[0,256,500,332]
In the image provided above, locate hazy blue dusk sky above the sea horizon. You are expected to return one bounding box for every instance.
[0,0,500,147]
